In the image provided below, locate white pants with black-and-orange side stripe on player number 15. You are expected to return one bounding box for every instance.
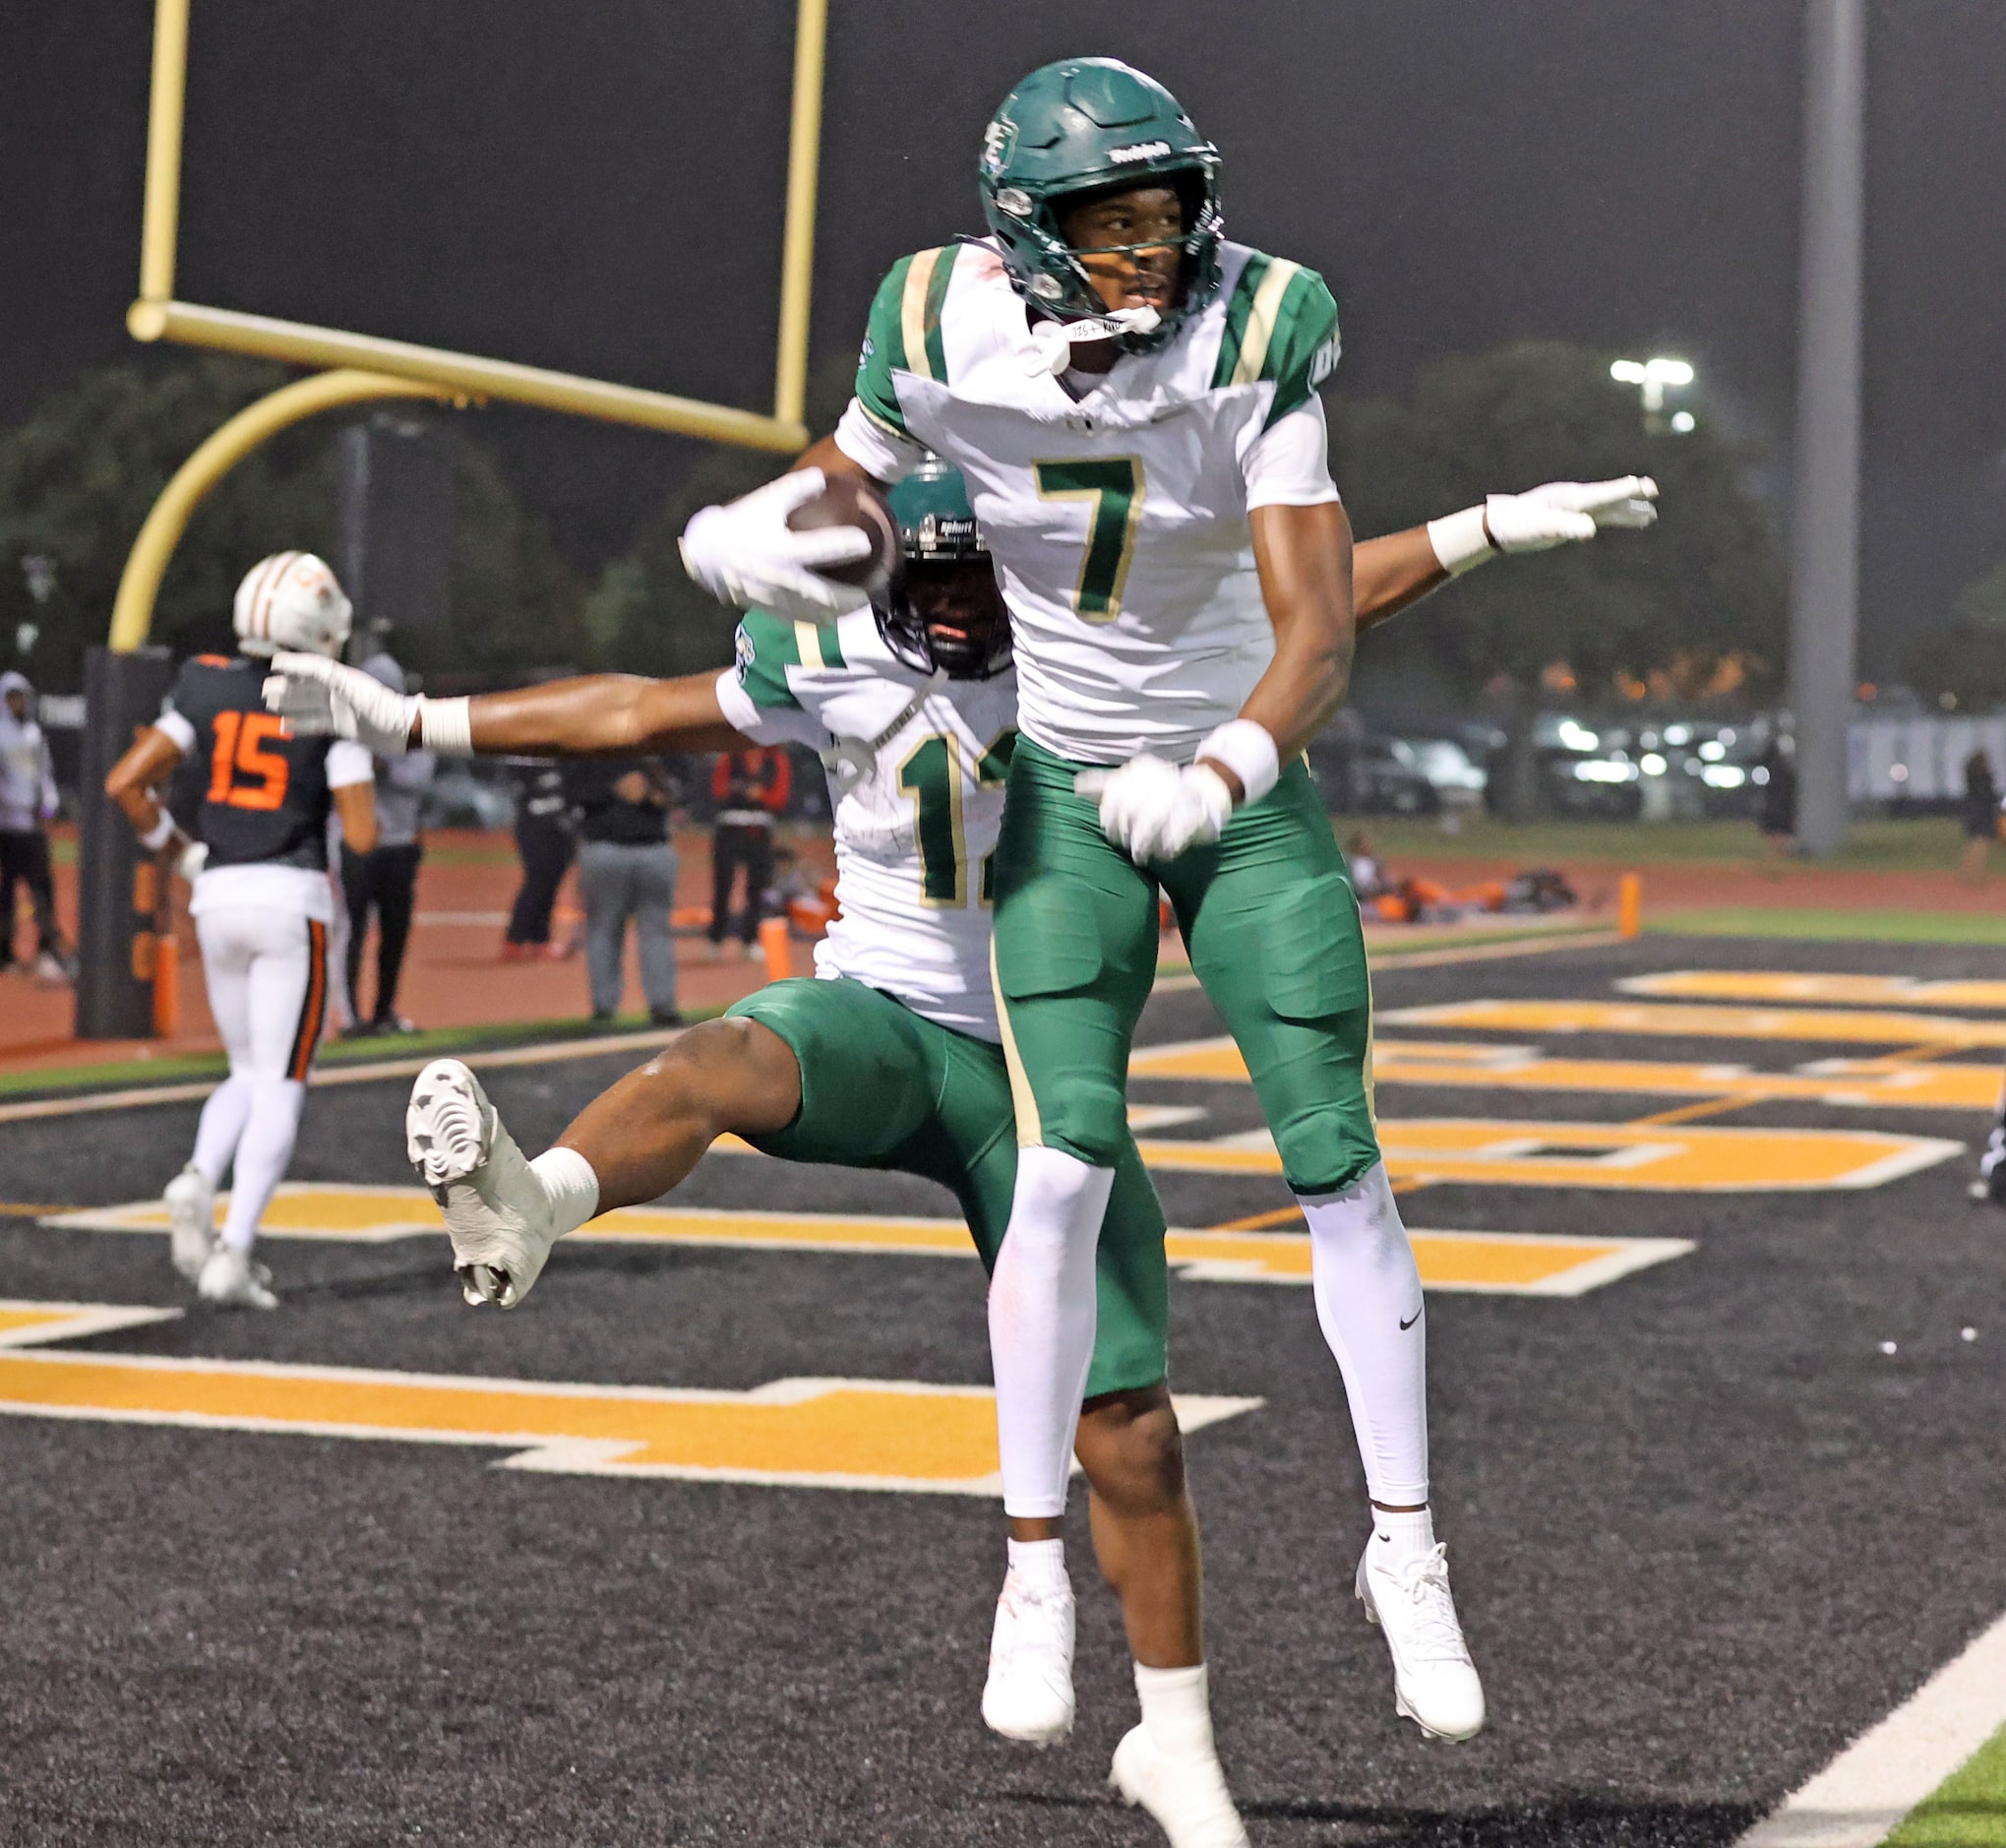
[193,905,327,1250]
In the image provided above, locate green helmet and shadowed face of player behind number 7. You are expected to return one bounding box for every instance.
[873,456,1009,680]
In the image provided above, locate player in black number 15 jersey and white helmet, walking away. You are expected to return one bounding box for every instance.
[104,552,377,1308]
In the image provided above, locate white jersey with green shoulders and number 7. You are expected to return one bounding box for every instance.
[836,243,1338,765]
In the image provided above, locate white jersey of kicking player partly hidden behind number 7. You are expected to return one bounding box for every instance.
[718,610,1017,1041]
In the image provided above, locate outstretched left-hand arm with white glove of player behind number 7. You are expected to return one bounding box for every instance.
[265,654,740,757]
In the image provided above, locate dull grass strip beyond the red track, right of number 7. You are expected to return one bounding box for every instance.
[1334,815,1964,873]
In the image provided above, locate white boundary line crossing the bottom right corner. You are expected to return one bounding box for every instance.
[1735,1618,2006,1848]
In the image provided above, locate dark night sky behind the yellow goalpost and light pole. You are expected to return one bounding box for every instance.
[0,0,2006,670]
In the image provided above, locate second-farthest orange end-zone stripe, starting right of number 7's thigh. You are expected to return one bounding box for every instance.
[1378,1002,2006,1045]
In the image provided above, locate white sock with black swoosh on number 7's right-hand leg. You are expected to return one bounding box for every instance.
[1302,1162,1429,1505]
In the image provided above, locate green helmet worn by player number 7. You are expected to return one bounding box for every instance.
[977,58,1224,353]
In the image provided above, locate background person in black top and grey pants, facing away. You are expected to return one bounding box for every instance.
[564,757,682,1027]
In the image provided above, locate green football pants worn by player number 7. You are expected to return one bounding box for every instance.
[995,738,1380,1194]
